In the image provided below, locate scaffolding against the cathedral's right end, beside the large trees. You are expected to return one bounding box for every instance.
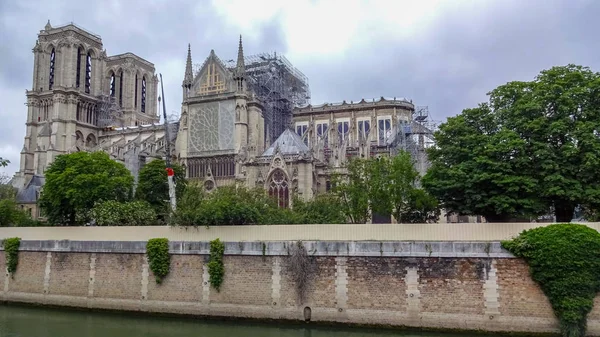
[389,106,439,176]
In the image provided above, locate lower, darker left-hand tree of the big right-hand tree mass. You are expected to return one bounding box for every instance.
[422,104,543,222]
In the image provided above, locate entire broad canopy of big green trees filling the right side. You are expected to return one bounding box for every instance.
[423,65,600,222]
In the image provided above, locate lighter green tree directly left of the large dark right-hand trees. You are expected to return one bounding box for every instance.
[333,151,439,223]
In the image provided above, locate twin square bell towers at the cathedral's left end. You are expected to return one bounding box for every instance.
[13,21,169,215]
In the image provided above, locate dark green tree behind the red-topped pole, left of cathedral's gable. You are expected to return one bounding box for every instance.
[135,159,187,217]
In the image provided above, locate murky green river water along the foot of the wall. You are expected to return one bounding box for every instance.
[0,305,498,337]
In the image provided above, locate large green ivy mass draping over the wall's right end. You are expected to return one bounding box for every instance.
[502,224,600,337]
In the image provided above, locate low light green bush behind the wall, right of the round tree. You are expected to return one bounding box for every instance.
[91,200,156,226]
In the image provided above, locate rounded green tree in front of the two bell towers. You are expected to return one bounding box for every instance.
[39,152,133,225]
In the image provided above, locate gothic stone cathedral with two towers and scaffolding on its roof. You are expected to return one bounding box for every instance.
[13,22,431,217]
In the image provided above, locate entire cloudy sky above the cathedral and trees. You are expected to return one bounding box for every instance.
[0,0,600,174]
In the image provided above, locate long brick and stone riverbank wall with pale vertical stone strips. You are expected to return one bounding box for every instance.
[0,224,600,336]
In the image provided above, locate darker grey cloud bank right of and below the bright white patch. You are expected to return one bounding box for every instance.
[299,0,600,119]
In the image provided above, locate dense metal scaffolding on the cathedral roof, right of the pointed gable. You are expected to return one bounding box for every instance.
[224,52,310,144]
